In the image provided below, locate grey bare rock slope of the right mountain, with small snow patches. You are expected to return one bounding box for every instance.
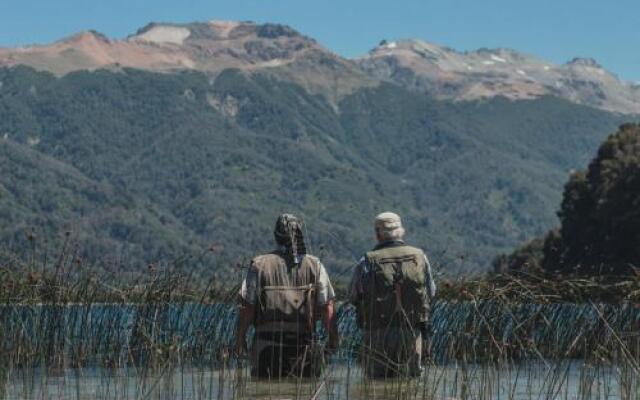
[355,40,640,114]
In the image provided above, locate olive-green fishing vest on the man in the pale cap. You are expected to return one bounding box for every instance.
[358,244,429,330]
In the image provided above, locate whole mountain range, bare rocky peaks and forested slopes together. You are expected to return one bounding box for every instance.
[0,21,640,275]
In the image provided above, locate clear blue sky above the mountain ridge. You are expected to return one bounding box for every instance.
[0,0,640,81]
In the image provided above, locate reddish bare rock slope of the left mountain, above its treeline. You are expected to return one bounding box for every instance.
[0,21,375,100]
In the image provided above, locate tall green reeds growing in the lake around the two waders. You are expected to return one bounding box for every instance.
[0,244,640,400]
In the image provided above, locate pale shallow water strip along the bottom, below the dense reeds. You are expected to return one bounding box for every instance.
[4,361,639,400]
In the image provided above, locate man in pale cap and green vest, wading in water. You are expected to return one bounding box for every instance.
[349,212,436,378]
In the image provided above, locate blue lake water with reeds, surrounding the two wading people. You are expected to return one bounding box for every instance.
[0,301,640,400]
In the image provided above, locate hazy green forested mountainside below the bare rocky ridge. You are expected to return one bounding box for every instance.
[0,67,623,274]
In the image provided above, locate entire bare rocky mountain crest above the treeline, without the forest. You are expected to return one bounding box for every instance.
[0,21,640,114]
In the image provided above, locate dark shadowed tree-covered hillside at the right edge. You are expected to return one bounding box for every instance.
[495,124,640,275]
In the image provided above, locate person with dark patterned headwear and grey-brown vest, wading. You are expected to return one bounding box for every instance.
[235,214,338,378]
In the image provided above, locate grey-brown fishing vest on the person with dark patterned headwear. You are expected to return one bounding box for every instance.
[253,253,320,333]
